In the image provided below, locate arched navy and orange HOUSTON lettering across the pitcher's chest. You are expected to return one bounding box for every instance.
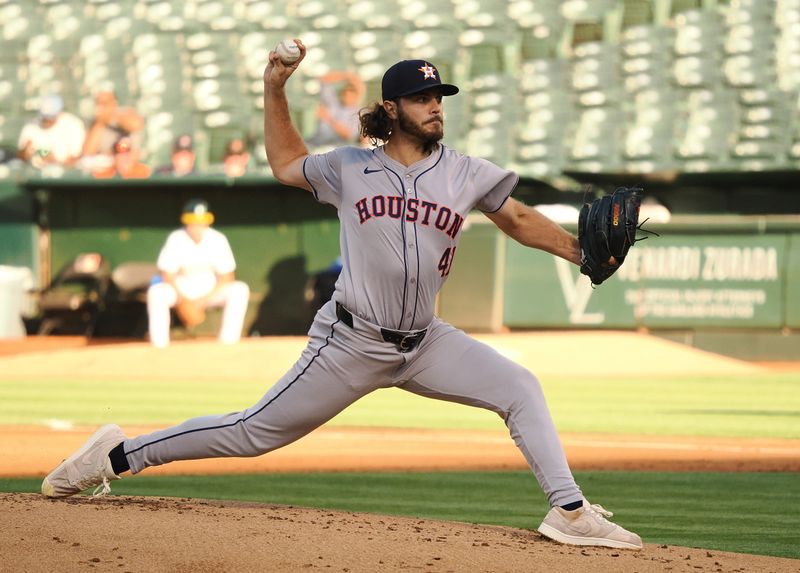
[355,195,464,239]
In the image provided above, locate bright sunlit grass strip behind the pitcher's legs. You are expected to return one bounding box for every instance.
[0,373,800,439]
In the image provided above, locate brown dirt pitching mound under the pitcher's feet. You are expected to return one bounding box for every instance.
[0,494,798,573]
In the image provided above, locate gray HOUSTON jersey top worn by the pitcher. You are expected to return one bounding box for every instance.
[304,146,518,330]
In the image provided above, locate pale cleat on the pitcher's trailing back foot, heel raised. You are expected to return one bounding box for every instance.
[42,424,125,497]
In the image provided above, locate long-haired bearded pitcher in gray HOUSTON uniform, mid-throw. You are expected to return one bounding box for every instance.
[42,40,642,549]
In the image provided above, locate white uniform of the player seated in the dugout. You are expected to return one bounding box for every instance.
[147,227,250,348]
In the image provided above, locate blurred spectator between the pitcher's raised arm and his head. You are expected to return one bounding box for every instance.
[307,71,366,146]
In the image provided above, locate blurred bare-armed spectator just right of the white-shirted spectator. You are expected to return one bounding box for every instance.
[83,91,144,165]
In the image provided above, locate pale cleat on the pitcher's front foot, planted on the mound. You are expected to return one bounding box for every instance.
[538,499,642,549]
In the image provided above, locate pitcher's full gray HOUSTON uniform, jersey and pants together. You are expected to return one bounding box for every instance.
[123,146,582,505]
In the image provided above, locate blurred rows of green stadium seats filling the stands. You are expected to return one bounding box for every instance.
[0,0,800,181]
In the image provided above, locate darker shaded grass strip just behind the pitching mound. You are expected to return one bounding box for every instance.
[0,471,800,567]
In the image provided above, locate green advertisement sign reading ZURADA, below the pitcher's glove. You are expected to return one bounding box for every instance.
[504,235,788,328]
